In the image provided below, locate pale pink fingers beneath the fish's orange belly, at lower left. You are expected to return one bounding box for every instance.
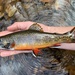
[0,50,32,57]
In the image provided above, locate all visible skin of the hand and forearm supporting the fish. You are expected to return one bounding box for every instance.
[0,21,75,57]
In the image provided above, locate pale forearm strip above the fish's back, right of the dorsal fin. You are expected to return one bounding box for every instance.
[40,24,75,34]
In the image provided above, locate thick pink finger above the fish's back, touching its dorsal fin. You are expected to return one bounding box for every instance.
[7,21,34,31]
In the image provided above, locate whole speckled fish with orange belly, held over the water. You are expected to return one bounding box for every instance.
[0,23,75,55]
